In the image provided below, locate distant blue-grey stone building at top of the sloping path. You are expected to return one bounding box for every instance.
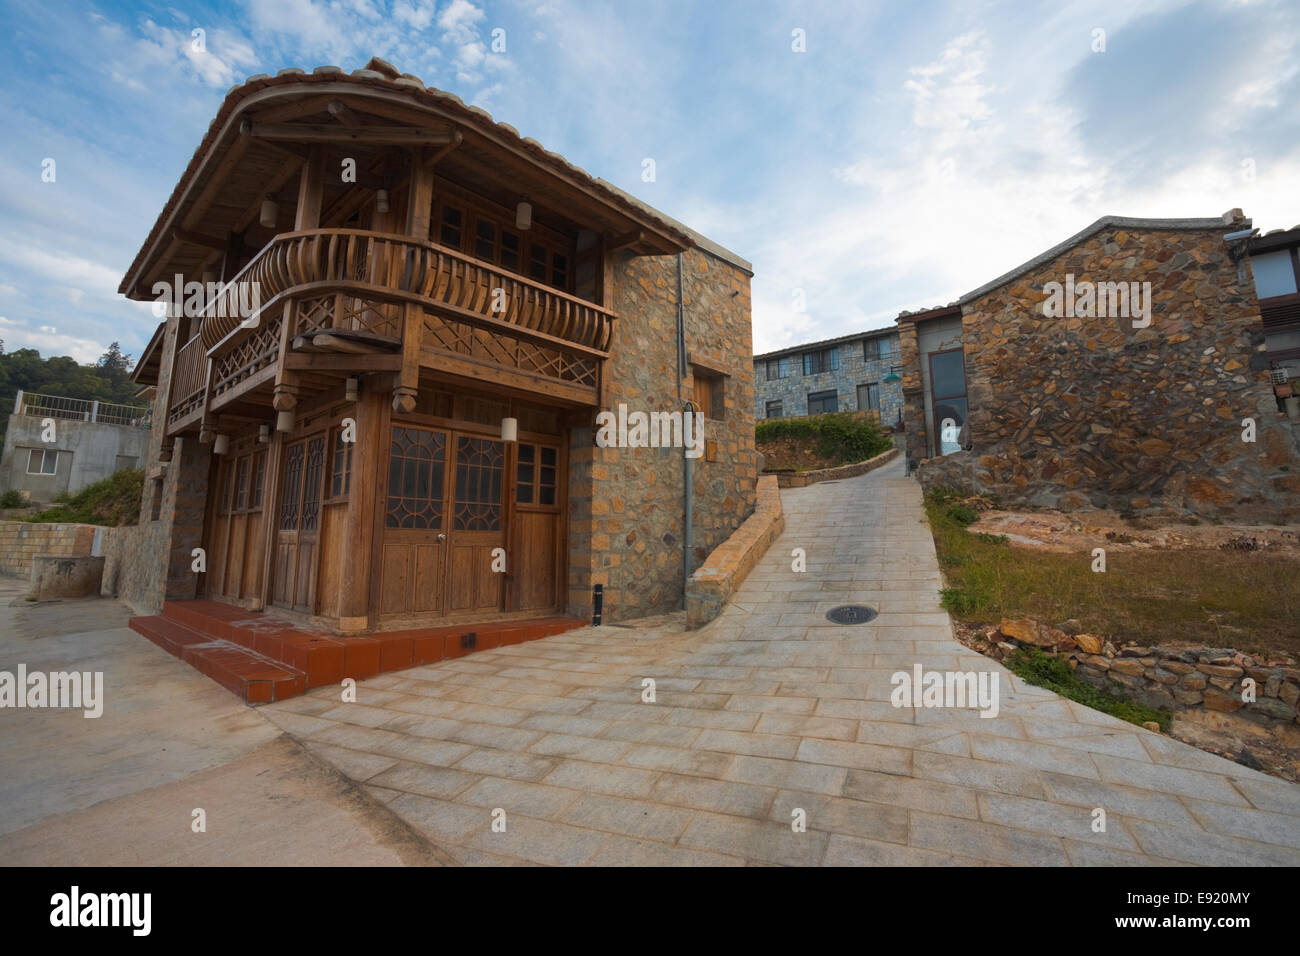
[754,329,902,425]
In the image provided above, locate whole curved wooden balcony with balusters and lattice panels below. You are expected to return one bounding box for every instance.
[168,229,615,433]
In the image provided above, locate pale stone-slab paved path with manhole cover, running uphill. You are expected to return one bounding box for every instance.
[261,462,1300,865]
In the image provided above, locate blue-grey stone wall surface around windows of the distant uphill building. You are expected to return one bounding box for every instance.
[754,332,902,425]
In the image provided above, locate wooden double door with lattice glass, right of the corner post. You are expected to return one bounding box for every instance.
[378,424,510,617]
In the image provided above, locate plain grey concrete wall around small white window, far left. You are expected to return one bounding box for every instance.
[0,415,150,502]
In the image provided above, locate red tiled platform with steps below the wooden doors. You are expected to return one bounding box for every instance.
[130,600,586,704]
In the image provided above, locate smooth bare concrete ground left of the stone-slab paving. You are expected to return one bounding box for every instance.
[0,578,449,866]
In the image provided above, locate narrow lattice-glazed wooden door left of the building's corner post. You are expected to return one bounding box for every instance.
[272,434,325,613]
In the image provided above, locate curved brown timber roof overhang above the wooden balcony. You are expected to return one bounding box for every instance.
[118,68,694,299]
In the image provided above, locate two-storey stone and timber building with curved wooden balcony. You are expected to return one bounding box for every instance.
[117,59,757,635]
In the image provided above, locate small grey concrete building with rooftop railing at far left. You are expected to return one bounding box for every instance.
[0,392,150,502]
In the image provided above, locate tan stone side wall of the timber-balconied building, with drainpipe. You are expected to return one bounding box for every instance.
[567,248,758,622]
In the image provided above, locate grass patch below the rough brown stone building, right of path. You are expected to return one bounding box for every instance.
[926,488,1300,656]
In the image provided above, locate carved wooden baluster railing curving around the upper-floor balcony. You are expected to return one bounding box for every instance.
[202,229,615,358]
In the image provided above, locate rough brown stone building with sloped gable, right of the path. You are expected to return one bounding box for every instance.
[898,209,1300,522]
